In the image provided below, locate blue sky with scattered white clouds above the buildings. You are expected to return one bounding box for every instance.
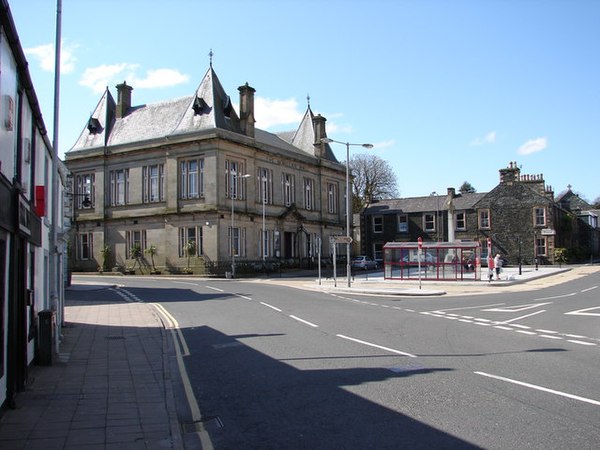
[9,0,600,201]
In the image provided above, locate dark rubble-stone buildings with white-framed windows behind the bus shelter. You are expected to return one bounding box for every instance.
[361,162,600,264]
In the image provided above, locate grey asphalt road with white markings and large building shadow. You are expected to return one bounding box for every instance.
[77,274,600,449]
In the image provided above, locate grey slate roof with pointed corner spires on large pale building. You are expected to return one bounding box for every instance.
[69,66,338,166]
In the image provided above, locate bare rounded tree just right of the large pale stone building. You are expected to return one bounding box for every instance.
[350,153,399,213]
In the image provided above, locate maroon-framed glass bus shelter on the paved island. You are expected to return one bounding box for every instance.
[383,241,481,281]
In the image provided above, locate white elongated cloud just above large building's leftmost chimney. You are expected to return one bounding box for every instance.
[79,63,189,94]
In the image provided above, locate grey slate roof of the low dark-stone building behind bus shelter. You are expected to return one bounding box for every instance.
[365,193,486,215]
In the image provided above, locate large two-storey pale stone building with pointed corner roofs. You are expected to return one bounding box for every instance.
[65,63,346,273]
